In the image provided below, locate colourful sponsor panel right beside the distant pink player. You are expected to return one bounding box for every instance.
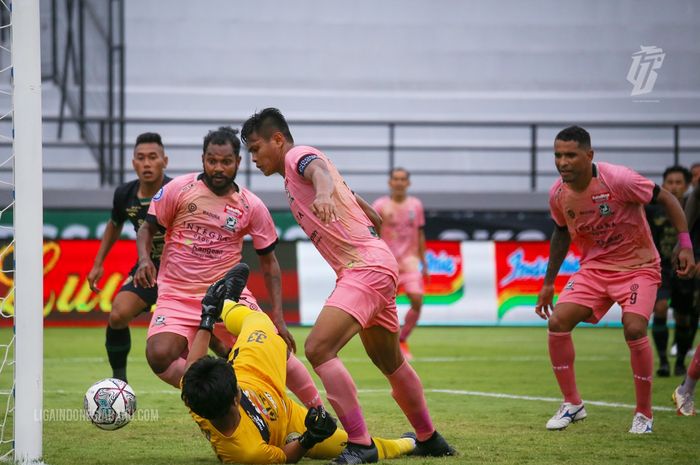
[396,241,464,305]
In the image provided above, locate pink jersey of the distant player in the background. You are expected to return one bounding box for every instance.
[372,196,425,273]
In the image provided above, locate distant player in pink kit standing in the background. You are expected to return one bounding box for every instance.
[372,168,428,361]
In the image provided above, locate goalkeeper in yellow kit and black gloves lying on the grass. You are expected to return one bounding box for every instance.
[181,263,415,463]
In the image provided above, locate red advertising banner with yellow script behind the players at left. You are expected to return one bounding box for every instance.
[0,240,299,326]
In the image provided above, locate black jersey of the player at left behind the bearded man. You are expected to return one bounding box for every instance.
[112,176,172,261]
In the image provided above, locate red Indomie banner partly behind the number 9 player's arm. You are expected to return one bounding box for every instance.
[494,242,581,320]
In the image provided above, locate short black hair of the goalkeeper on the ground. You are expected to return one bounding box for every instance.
[180,355,238,420]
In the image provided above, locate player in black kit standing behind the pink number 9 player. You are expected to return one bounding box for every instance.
[646,166,697,377]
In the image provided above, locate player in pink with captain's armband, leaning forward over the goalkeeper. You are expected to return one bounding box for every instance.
[241,108,455,464]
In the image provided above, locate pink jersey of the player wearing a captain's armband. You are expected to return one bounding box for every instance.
[284,146,398,279]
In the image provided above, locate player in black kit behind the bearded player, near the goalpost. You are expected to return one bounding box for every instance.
[87,132,170,381]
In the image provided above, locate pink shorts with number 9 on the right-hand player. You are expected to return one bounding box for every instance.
[557,268,661,323]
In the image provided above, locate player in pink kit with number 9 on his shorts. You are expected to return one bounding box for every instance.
[535,126,694,434]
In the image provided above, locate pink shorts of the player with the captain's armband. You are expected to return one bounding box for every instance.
[325,268,399,333]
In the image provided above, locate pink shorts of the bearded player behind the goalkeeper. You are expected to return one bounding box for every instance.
[147,290,260,348]
